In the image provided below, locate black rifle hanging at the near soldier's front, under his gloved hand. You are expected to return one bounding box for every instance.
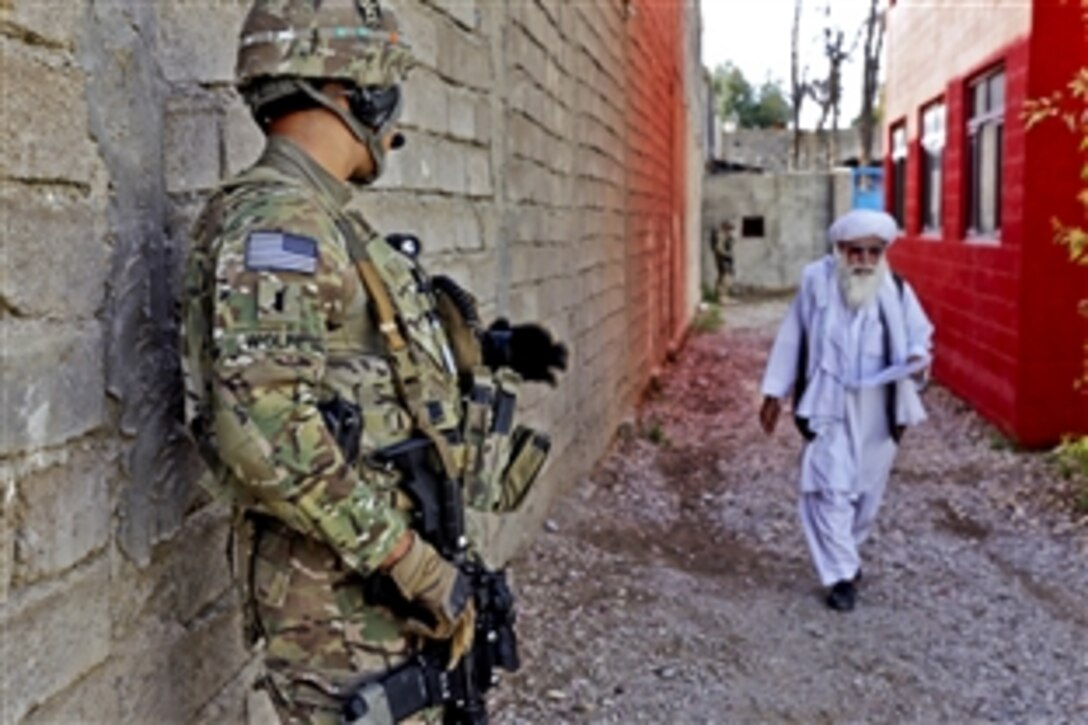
[343,438,520,725]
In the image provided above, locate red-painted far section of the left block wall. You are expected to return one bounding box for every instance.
[627,0,687,370]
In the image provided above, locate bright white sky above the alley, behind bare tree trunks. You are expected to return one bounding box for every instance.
[702,0,869,128]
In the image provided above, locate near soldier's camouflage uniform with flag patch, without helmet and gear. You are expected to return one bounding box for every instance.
[183,137,460,677]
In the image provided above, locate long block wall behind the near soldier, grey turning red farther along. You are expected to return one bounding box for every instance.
[0,0,705,723]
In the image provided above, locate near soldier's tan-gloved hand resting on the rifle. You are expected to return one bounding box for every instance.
[390,537,475,668]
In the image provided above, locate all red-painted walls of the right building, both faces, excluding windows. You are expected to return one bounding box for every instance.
[886,0,1088,446]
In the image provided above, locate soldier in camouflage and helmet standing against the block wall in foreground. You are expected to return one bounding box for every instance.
[183,0,566,723]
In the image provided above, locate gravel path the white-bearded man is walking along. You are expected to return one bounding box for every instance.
[493,300,1088,724]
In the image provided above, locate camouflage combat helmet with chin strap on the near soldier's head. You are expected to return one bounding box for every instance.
[235,0,415,182]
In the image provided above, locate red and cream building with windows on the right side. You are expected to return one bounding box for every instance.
[885,0,1088,446]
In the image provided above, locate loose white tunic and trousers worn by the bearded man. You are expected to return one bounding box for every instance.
[763,256,934,587]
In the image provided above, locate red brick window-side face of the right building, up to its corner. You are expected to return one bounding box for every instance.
[889,40,1027,431]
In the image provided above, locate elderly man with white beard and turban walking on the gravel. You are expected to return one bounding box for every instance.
[759,209,934,612]
